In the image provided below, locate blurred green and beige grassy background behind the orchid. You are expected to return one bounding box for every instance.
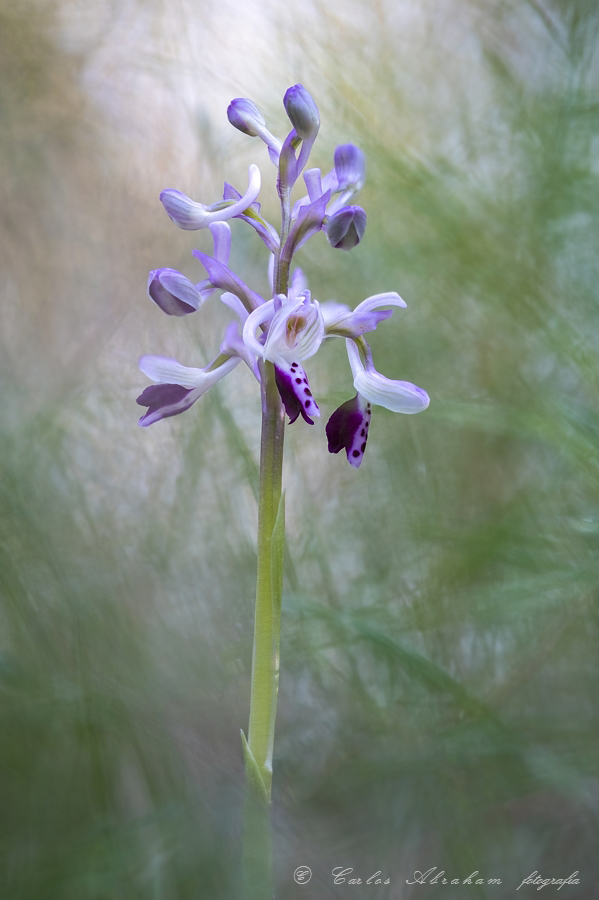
[0,0,599,900]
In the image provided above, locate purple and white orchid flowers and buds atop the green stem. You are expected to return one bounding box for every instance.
[137,84,429,467]
